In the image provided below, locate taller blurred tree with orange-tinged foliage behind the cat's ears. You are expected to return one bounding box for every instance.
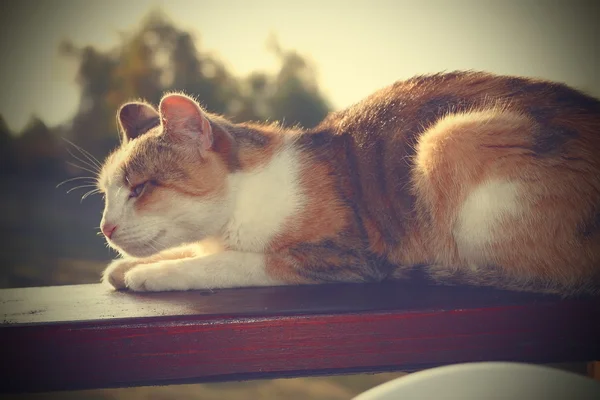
[60,11,237,158]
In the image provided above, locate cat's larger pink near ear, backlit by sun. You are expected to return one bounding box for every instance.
[158,94,213,151]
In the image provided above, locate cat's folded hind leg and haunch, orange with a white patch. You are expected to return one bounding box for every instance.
[413,110,600,294]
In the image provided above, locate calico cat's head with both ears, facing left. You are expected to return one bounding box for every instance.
[99,94,233,257]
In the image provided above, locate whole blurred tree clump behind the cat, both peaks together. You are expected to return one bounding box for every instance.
[53,10,329,169]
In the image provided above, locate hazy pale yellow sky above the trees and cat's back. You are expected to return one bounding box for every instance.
[0,0,600,129]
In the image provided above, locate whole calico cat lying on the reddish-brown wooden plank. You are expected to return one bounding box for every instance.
[99,71,600,296]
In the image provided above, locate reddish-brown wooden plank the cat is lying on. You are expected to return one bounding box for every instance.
[0,282,600,392]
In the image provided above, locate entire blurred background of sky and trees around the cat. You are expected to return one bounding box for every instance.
[0,0,600,399]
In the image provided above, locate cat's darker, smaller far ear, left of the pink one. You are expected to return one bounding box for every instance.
[117,102,160,143]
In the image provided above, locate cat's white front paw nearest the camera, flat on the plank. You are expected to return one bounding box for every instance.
[125,261,189,292]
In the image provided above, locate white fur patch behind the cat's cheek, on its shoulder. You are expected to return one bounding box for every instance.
[225,148,305,252]
